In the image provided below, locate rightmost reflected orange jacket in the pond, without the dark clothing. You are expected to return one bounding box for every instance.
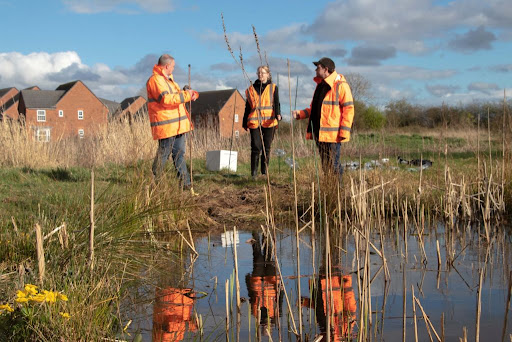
[321,275,357,341]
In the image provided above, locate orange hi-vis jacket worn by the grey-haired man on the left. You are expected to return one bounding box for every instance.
[146,65,193,140]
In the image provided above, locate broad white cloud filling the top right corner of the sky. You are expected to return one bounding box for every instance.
[304,0,512,54]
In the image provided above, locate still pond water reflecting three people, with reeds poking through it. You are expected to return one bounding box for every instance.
[124,225,512,341]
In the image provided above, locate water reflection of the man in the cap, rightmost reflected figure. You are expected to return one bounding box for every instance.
[302,268,357,341]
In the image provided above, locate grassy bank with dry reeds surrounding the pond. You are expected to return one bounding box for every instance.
[0,117,512,341]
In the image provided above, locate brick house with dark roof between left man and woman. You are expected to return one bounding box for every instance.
[192,89,247,138]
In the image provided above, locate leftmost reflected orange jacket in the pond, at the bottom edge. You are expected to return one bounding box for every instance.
[153,287,197,342]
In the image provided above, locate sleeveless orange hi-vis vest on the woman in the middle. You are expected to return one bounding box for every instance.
[245,83,277,129]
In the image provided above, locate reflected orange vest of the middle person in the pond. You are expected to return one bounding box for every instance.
[248,275,279,320]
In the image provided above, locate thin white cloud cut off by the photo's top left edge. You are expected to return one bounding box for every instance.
[62,0,174,14]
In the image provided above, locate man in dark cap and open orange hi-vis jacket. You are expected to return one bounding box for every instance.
[292,57,354,184]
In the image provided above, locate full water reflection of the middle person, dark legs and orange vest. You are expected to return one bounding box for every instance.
[245,232,283,326]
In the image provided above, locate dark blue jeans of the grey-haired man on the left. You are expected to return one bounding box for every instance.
[153,134,190,187]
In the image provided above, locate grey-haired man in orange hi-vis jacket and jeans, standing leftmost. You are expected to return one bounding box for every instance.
[146,54,199,189]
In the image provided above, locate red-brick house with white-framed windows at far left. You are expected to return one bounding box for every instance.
[18,81,108,141]
